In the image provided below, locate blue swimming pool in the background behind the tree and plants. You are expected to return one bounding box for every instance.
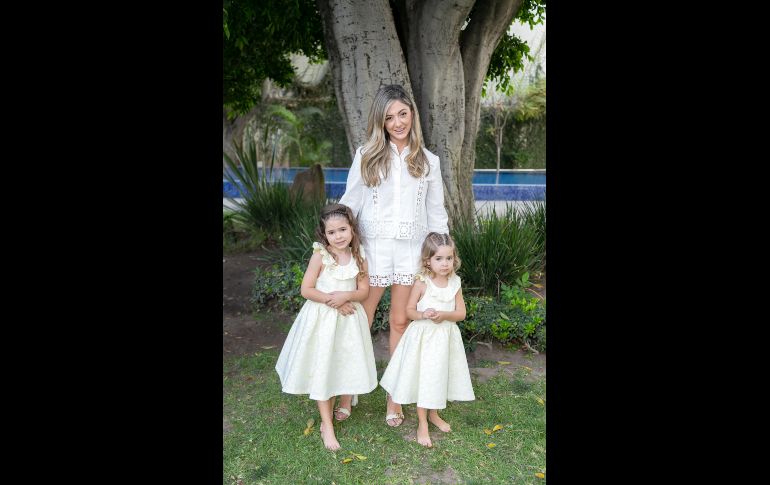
[222,167,545,200]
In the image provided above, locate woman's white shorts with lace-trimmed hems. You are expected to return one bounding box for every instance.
[362,238,422,287]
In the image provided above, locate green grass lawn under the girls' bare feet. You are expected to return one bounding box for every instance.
[222,349,546,485]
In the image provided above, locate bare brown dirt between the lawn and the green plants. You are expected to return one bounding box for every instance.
[222,252,546,381]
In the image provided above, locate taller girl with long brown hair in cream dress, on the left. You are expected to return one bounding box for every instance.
[275,204,377,450]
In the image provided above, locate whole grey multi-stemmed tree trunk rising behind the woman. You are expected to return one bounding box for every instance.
[316,0,522,227]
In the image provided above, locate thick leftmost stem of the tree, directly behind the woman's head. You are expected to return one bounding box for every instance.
[317,0,411,161]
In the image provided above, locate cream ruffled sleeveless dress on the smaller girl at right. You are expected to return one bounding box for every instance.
[380,275,476,409]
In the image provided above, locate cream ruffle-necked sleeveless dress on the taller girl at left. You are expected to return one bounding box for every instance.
[275,242,377,401]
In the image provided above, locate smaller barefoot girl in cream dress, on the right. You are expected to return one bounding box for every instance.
[380,232,476,447]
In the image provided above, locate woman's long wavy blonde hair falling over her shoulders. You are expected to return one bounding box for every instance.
[361,84,430,187]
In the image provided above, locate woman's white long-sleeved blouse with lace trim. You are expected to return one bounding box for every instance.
[340,142,449,242]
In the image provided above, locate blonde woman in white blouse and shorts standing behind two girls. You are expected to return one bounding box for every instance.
[335,85,449,426]
